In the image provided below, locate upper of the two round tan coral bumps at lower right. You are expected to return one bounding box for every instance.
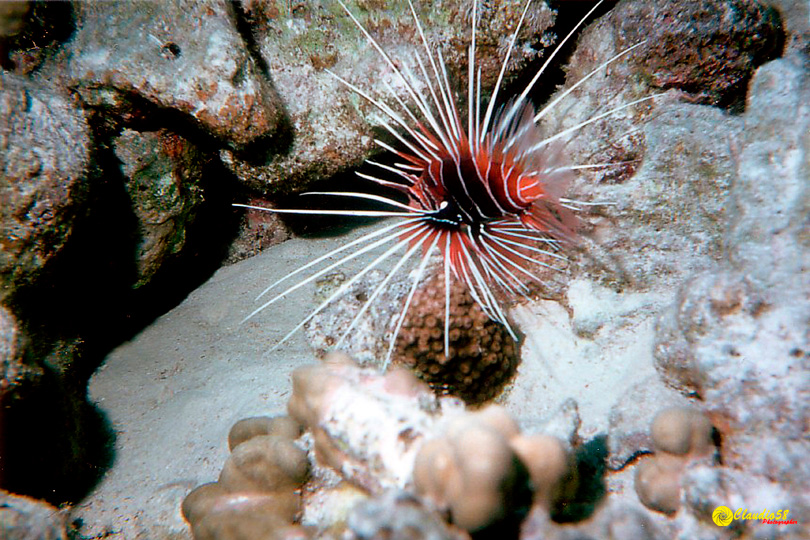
[650,407,713,456]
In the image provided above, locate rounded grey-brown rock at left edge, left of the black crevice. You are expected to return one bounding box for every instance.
[0,71,90,300]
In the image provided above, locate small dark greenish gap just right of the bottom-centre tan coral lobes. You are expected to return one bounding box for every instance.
[550,435,608,523]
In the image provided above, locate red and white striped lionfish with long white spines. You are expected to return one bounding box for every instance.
[235,0,655,366]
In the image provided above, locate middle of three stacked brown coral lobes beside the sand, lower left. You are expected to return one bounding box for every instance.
[219,435,308,491]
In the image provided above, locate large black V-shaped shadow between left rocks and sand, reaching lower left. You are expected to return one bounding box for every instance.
[0,109,239,506]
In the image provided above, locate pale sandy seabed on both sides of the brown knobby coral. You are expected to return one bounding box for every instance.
[75,221,655,540]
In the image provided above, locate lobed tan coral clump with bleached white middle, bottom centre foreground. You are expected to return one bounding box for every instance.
[280,353,570,531]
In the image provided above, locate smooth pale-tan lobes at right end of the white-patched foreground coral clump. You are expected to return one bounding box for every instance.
[413,406,571,532]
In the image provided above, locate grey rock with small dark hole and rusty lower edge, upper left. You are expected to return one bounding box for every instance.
[67,0,283,149]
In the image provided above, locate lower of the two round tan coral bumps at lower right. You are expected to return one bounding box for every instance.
[636,454,684,515]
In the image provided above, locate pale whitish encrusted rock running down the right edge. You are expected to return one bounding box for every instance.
[655,57,810,535]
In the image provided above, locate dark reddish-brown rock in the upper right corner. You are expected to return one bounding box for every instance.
[610,0,784,107]
